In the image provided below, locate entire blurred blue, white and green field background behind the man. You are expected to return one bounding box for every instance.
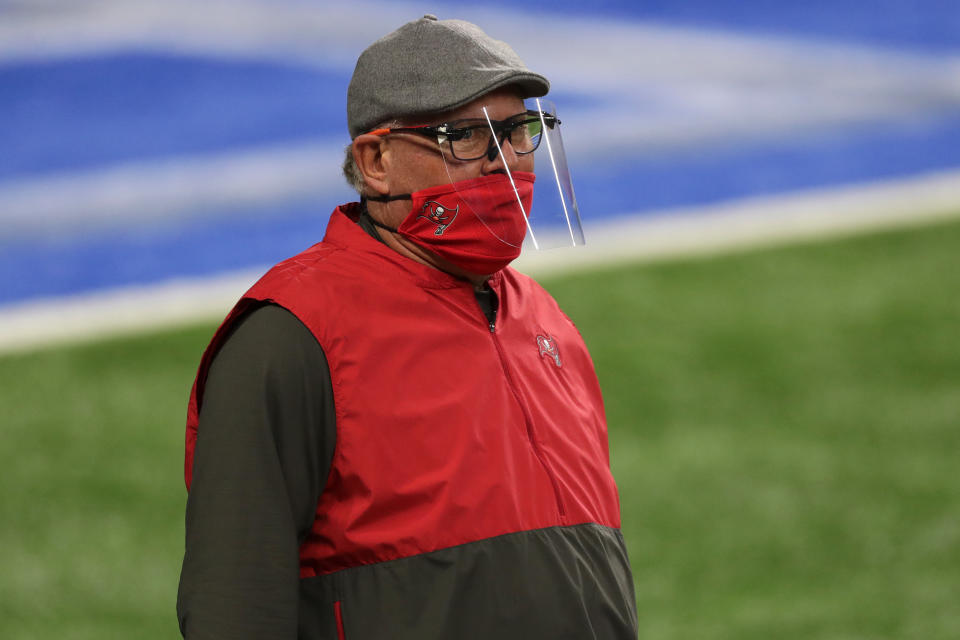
[0,0,960,639]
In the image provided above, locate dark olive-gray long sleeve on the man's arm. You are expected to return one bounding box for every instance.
[177,305,336,640]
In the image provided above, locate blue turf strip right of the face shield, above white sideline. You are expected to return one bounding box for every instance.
[570,114,960,220]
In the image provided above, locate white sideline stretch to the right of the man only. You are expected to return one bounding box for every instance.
[514,170,960,276]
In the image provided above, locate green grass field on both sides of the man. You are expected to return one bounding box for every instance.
[0,222,960,640]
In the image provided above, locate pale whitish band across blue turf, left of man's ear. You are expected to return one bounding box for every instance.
[0,141,349,238]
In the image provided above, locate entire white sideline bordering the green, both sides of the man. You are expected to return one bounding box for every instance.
[0,171,960,353]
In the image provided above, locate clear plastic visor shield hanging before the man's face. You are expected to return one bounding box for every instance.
[437,98,584,250]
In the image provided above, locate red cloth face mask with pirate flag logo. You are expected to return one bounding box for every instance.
[369,171,536,275]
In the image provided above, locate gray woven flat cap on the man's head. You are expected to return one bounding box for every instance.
[347,15,550,139]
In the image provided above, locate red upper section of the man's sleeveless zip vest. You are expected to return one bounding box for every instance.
[185,205,620,577]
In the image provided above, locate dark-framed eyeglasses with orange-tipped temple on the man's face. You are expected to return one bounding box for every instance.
[370,111,560,160]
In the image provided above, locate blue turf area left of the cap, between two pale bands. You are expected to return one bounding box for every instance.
[0,52,350,180]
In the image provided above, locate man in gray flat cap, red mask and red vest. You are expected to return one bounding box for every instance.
[177,16,636,640]
